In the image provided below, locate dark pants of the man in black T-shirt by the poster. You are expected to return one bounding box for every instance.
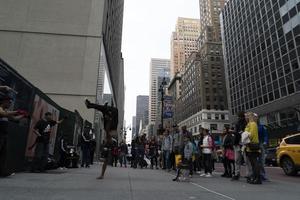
[31,142,49,171]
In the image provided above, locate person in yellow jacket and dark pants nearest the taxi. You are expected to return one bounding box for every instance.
[245,112,262,184]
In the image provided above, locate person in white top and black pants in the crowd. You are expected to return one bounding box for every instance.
[201,128,213,178]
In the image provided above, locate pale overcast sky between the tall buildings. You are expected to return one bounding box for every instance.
[122,0,199,139]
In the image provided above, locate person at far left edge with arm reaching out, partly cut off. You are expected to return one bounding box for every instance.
[0,94,24,177]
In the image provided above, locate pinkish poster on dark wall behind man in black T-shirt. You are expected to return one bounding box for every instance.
[25,95,59,157]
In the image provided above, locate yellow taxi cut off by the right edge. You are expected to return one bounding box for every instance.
[276,133,300,176]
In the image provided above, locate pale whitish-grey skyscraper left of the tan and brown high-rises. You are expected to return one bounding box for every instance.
[149,58,170,124]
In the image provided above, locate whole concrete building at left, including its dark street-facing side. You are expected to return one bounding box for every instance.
[0,0,124,151]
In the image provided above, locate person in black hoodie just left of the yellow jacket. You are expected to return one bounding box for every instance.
[232,112,247,180]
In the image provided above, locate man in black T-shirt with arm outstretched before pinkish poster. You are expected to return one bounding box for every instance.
[31,112,64,172]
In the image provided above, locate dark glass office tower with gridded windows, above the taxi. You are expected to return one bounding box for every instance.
[222,0,300,137]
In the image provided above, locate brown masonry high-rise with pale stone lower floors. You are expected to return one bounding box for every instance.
[177,0,229,136]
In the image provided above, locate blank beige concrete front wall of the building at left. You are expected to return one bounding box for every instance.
[0,0,109,121]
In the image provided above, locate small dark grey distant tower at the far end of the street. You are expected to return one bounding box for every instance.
[136,95,149,134]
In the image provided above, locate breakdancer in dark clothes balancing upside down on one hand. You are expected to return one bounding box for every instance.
[85,99,118,179]
